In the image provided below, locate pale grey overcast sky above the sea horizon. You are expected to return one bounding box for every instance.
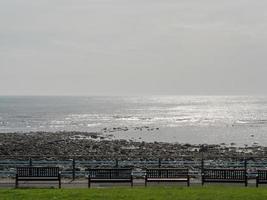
[0,0,267,95]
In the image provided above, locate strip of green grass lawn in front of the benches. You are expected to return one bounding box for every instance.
[0,186,267,200]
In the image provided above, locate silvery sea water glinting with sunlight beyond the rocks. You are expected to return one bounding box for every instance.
[0,96,267,146]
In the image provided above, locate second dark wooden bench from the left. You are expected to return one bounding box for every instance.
[88,168,133,188]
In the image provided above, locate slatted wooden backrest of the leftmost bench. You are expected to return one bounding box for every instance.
[17,167,59,177]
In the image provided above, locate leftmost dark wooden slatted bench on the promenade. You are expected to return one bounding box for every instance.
[15,167,61,188]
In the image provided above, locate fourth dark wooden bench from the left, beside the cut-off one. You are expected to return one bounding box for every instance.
[202,169,248,186]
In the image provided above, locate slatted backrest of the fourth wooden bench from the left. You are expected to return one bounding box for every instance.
[203,169,246,180]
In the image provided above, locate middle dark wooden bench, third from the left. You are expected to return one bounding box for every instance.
[145,168,190,187]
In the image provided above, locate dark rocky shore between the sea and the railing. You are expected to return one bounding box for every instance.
[0,132,267,160]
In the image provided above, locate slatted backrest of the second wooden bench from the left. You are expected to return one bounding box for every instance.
[88,168,132,179]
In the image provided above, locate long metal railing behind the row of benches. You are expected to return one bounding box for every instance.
[0,155,267,180]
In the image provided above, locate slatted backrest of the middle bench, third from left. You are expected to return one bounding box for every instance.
[146,168,189,178]
